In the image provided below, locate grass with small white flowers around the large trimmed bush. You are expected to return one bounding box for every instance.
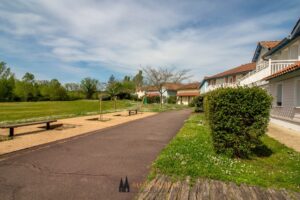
[149,114,300,192]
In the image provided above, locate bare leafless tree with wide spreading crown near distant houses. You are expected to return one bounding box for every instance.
[143,67,190,108]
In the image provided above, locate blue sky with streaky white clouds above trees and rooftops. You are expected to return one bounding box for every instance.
[0,0,300,83]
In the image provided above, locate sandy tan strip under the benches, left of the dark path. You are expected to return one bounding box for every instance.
[0,111,156,154]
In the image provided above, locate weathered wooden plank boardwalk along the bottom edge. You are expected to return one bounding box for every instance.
[137,176,300,200]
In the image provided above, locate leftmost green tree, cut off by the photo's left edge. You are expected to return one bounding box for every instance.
[0,62,15,101]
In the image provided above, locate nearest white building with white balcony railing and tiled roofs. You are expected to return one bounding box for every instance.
[239,19,300,131]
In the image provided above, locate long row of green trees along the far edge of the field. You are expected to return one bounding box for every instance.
[0,62,144,102]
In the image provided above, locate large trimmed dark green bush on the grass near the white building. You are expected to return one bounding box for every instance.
[204,87,272,158]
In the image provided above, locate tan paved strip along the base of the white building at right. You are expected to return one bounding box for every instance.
[267,123,300,152]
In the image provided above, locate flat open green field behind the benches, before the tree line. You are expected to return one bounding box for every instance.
[0,100,136,123]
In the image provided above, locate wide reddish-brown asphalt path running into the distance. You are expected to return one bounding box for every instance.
[0,110,190,200]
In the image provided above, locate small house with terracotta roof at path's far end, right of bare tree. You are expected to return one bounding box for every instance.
[177,82,200,105]
